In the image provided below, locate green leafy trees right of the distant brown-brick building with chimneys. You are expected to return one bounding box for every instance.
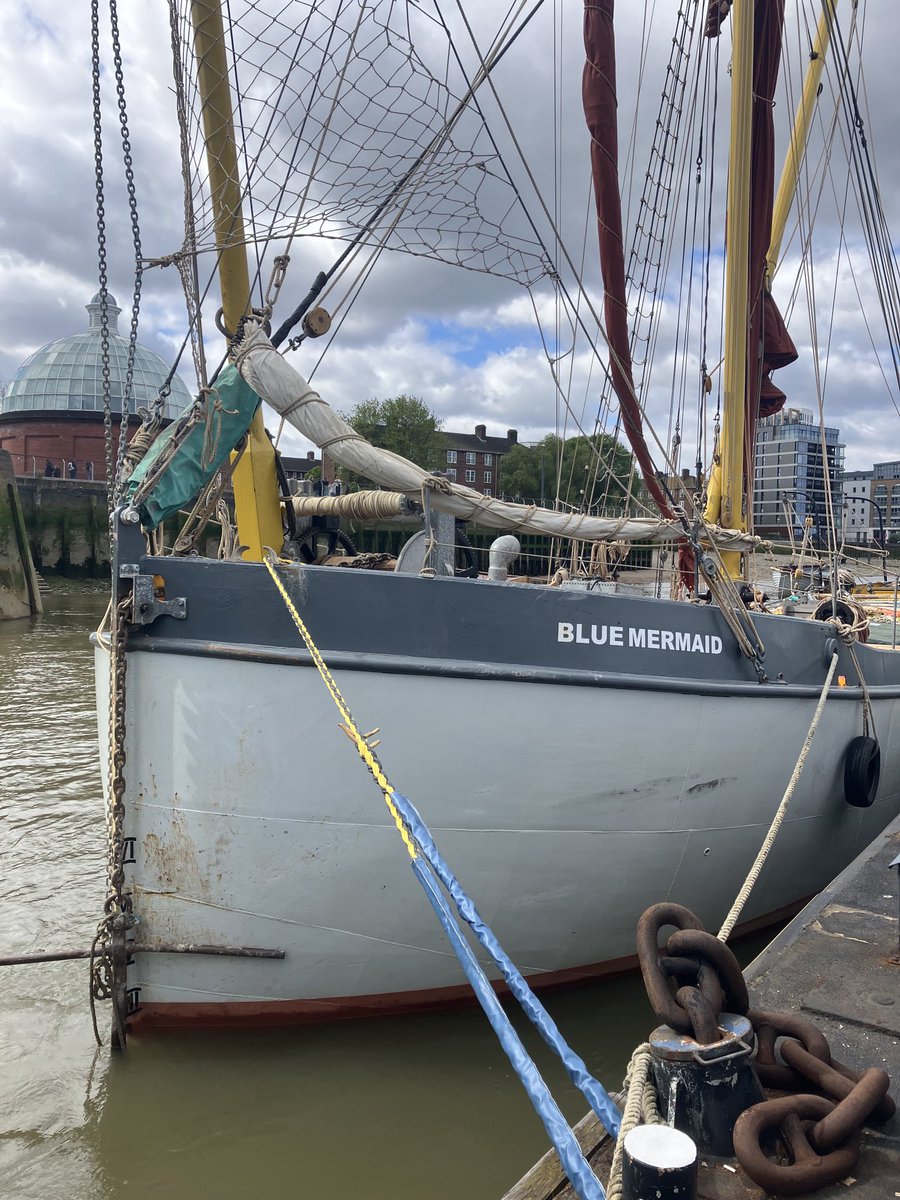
[500,433,632,510]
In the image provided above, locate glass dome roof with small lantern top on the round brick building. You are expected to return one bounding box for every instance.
[0,292,191,420]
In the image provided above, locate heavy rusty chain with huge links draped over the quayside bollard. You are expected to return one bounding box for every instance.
[637,902,896,1195]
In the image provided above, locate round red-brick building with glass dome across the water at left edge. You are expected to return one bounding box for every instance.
[0,293,191,480]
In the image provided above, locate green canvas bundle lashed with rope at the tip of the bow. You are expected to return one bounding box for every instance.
[125,365,260,529]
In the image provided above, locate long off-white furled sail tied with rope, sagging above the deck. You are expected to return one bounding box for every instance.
[232,320,760,550]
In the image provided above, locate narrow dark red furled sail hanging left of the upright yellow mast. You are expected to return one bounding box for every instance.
[582,0,672,517]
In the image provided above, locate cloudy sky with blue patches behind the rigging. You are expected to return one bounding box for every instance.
[0,0,900,480]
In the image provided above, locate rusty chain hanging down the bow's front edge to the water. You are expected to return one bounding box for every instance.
[90,595,134,1049]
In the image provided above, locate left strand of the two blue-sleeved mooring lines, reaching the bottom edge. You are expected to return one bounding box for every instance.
[412,859,606,1200]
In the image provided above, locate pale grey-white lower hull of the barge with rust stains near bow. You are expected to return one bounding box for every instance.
[97,624,900,1020]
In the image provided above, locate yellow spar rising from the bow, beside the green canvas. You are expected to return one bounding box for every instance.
[191,0,283,562]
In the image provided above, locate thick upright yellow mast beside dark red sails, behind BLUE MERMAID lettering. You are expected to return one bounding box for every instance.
[706,0,754,578]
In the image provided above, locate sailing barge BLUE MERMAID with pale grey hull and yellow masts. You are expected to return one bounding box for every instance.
[96,0,900,1027]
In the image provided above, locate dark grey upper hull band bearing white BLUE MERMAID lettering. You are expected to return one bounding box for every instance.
[128,557,900,701]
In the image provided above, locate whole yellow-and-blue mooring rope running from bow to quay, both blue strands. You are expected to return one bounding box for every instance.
[264,551,622,1200]
